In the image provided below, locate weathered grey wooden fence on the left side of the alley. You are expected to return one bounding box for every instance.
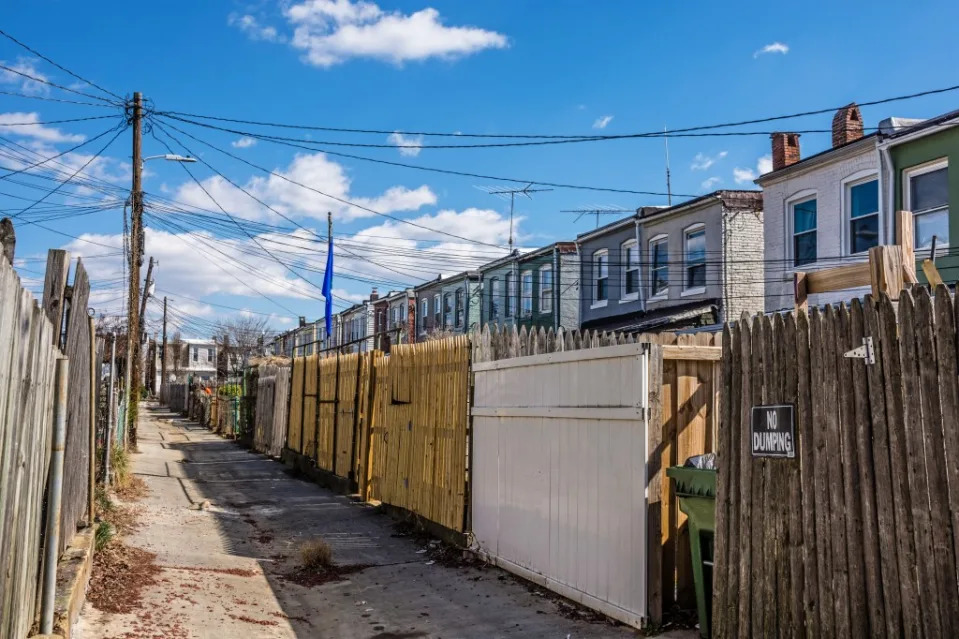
[0,251,95,637]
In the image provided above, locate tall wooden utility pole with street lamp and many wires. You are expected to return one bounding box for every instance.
[126,91,143,448]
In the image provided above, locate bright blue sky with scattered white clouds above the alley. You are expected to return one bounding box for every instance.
[0,0,959,337]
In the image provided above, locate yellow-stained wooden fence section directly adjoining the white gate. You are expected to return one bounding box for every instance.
[369,336,470,532]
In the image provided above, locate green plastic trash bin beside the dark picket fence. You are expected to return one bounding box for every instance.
[666,462,716,637]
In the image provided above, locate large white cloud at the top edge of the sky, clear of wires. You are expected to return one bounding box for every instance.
[272,0,508,67]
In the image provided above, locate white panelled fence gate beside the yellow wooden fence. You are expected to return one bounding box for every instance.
[471,344,649,627]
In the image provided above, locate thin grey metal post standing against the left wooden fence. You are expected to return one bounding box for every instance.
[40,357,70,635]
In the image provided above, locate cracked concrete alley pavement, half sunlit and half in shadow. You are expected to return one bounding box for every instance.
[75,405,637,639]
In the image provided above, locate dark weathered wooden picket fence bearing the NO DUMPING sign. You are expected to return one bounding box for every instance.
[713,287,959,637]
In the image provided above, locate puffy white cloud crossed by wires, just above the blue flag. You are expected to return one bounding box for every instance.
[175,153,436,221]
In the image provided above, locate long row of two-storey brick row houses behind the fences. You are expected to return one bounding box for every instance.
[273,104,959,356]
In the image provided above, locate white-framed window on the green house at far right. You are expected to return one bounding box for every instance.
[905,161,949,249]
